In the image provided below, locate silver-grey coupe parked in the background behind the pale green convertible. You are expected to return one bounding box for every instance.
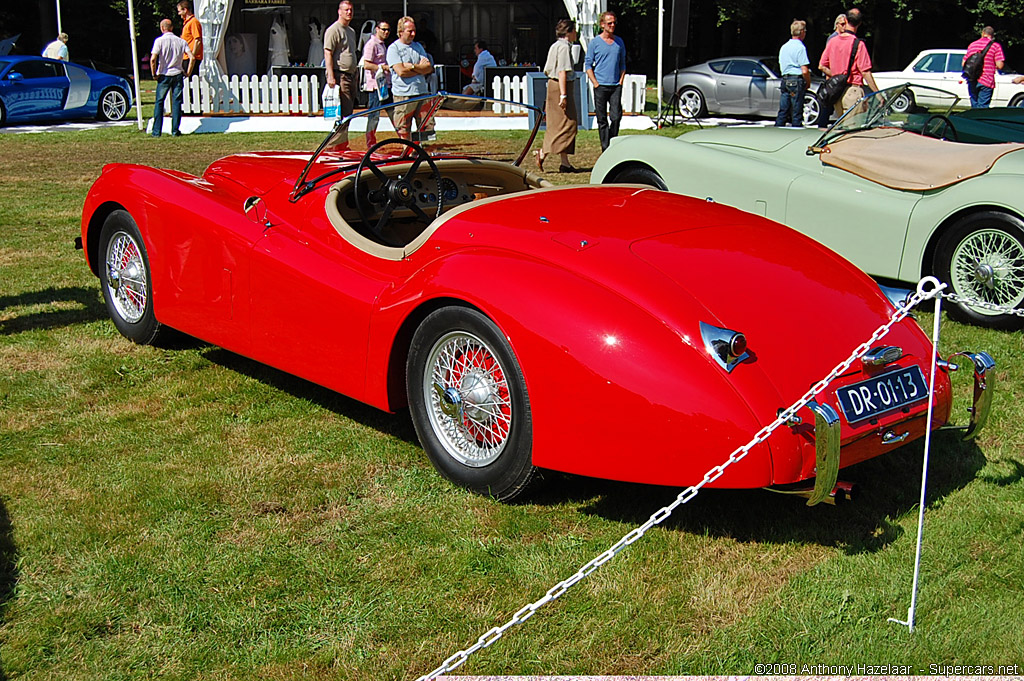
[662,56,821,126]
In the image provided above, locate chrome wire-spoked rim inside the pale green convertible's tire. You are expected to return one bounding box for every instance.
[950,228,1024,316]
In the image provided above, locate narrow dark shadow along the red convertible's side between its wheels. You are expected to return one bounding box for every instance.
[203,346,420,446]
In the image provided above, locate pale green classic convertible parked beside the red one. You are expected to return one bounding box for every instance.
[591,85,1024,329]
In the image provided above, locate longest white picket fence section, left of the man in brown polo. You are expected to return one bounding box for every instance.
[181,76,323,116]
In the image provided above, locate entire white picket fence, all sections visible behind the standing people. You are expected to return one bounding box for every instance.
[175,74,647,116]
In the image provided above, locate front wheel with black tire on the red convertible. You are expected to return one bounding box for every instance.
[96,210,164,345]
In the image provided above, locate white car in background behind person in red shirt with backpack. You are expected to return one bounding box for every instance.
[874,49,1024,114]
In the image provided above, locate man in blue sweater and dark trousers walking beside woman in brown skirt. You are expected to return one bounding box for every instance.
[583,12,626,151]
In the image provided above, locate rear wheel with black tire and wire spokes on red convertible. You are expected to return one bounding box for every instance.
[406,307,537,501]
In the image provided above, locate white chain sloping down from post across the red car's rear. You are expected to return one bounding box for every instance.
[417,276,946,681]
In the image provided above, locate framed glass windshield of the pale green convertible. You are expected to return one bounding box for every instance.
[807,83,959,154]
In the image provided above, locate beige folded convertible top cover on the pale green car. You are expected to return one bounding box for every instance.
[820,128,1024,191]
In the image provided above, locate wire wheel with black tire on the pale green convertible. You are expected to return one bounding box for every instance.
[933,211,1024,330]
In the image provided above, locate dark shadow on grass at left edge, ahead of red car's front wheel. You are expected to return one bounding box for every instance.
[0,286,106,336]
